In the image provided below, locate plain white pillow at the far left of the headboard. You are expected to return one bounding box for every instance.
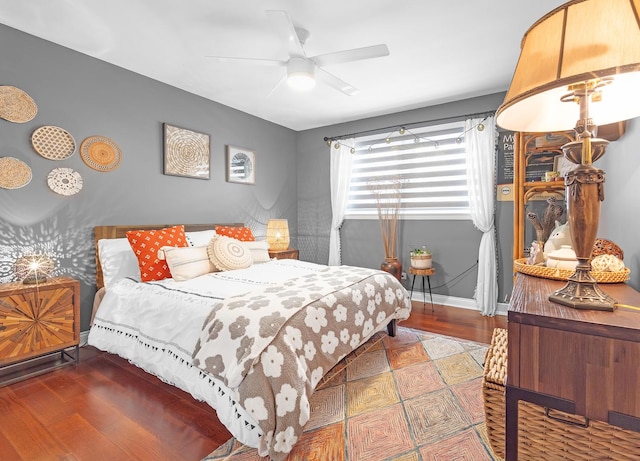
[98,238,140,287]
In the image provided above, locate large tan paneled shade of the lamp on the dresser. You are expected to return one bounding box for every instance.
[496,0,640,132]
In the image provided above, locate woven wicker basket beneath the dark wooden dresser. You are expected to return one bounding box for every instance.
[482,328,640,461]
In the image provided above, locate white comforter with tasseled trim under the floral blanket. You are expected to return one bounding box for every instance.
[89,260,408,447]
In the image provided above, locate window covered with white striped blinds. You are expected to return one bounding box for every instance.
[347,120,471,219]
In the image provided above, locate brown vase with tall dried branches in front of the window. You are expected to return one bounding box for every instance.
[368,178,402,280]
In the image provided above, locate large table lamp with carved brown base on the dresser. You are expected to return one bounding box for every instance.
[496,0,640,311]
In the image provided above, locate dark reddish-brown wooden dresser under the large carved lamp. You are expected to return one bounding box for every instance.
[506,274,640,460]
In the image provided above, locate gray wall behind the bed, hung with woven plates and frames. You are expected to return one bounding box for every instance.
[0,25,298,330]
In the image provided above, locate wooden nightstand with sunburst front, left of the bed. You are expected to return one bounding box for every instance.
[0,277,80,386]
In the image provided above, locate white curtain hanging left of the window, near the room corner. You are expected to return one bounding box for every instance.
[329,139,355,266]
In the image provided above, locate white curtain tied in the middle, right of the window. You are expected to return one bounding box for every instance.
[465,117,498,315]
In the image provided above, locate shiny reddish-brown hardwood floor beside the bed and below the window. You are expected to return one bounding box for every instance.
[0,301,507,461]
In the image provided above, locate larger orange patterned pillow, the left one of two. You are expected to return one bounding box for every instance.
[127,226,189,282]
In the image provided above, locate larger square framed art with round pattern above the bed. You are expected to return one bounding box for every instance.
[164,123,211,179]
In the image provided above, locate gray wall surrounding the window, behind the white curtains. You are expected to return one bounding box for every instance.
[296,93,513,301]
